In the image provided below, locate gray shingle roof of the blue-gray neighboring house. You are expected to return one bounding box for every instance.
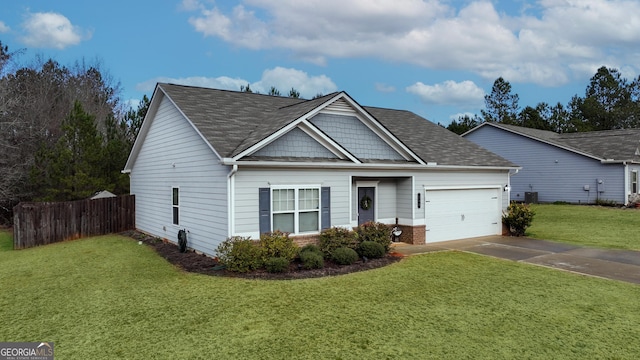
[489,123,640,162]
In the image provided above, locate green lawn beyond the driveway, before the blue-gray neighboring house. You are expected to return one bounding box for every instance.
[527,204,640,250]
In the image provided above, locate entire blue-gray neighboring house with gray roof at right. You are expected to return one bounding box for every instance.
[462,122,640,205]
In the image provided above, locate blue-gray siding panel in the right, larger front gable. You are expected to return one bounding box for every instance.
[310,113,404,160]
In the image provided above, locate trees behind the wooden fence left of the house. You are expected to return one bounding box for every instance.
[0,42,149,223]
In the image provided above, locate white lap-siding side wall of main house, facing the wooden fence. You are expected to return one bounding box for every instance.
[131,98,231,254]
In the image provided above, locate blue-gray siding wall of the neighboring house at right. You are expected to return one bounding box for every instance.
[465,126,626,203]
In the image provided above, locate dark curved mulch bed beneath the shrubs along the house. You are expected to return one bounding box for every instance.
[122,231,402,280]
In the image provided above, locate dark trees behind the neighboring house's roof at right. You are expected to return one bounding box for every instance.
[447,66,640,134]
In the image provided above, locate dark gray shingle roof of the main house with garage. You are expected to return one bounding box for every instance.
[158,84,517,167]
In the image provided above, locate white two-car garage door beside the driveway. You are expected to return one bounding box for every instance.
[424,188,502,243]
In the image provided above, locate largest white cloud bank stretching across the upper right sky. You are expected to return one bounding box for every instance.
[185,0,640,85]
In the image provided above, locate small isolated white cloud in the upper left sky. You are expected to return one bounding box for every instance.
[22,12,91,49]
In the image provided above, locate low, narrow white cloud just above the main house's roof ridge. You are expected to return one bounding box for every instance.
[136,67,337,99]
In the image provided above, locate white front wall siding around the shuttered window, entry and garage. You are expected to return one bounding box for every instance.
[233,166,509,238]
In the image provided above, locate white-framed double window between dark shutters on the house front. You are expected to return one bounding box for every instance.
[271,186,320,234]
